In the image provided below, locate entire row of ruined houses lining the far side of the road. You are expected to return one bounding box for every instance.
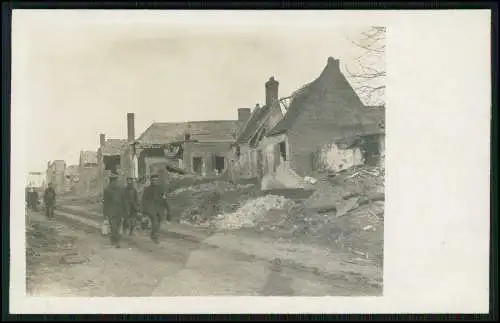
[47,57,385,193]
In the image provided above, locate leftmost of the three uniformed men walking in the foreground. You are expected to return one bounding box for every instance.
[103,173,123,248]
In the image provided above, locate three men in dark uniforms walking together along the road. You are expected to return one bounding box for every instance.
[103,174,171,248]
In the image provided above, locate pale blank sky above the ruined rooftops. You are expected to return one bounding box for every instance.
[12,10,376,171]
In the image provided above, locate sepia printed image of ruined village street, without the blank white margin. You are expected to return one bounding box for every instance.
[17,10,387,297]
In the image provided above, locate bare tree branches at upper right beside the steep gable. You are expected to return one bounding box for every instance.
[346,26,386,105]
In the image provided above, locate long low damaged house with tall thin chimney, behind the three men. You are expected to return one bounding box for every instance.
[122,114,243,182]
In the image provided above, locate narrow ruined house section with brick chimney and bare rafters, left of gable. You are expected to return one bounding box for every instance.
[229,77,283,179]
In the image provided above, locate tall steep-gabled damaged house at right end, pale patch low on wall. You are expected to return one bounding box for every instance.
[259,57,385,185]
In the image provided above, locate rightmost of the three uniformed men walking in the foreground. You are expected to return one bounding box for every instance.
[142,174,170,243]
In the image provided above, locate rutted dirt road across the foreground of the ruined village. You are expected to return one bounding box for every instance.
[26,213,374,297]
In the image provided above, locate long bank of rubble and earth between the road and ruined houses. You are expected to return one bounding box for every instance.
[173,166,385,262]
